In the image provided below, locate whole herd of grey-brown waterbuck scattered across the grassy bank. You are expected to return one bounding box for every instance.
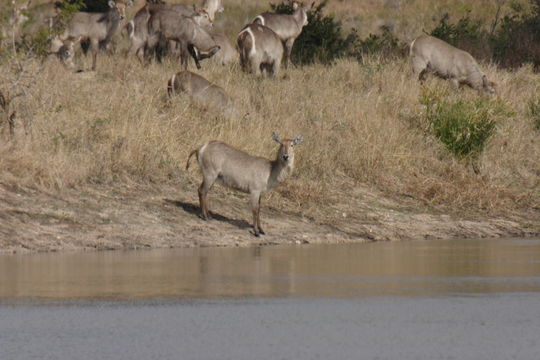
[3,0,495,236]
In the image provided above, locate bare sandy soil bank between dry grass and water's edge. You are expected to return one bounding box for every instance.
[0,184,540,253]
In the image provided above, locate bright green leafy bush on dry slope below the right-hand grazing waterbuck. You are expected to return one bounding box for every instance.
[420,90,510,158]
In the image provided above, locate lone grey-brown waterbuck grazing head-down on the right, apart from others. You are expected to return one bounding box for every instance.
[410,34,496,95]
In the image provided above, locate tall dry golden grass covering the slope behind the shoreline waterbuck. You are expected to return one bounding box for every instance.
[0,0,540,225]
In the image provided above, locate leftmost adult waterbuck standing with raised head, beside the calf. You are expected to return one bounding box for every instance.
[61,0,132,70]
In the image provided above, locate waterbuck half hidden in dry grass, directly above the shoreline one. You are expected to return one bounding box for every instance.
[167,71,233,116]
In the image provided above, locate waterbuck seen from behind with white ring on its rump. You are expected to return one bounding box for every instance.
[237,24,283,76]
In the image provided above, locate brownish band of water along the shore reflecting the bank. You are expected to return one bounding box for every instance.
[0,239,540,302]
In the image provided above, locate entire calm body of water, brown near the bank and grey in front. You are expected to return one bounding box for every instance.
[0,239,540,360]
